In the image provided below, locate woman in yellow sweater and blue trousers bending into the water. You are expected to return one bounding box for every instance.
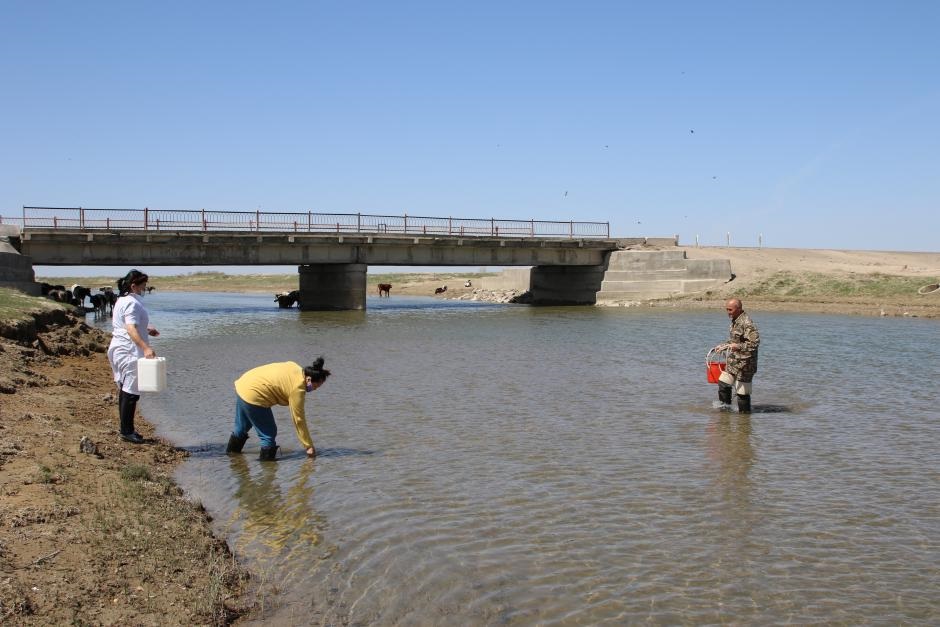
[225,357,330,461]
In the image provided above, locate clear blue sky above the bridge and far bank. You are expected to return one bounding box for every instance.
[0,0,940,251]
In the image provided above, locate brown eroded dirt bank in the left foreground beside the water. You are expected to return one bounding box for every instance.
[0,289,251,625]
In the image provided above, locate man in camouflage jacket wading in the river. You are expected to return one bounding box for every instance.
[718,298,760,413]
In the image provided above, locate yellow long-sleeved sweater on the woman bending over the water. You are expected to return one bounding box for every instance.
[235,361,313,448]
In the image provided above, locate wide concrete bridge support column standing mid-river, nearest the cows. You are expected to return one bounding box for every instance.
[297,263,368,311]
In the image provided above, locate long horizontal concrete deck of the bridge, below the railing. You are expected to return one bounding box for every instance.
[20,228,626,266]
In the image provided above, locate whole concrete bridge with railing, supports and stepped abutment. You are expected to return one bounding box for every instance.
[0,208,730,310]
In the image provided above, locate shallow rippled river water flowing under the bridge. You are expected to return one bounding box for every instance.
[90,292,940,625]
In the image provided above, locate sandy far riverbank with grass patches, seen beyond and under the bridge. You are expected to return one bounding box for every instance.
[37,247,940,318]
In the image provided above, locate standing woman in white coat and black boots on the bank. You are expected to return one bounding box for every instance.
[108,270,160,444]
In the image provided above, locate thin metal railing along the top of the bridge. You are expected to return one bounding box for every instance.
[0,207,610,239]
